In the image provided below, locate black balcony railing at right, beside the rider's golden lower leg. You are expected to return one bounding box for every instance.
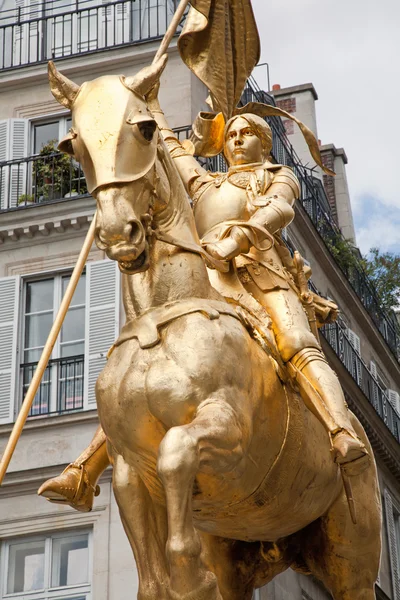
[320,322,400,443]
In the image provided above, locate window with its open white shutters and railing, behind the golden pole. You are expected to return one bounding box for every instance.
[0,258,120,424]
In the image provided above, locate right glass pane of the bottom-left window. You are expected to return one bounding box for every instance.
[51,534,89,587]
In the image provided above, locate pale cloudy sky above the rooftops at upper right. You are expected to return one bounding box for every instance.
[252,0,400,254]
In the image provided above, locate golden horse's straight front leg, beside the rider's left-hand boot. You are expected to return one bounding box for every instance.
[109,449,170,600]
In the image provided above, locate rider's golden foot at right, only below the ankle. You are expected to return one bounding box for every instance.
[332,429,370,477]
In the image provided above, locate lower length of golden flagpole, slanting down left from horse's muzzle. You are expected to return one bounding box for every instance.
[0,213,96,485]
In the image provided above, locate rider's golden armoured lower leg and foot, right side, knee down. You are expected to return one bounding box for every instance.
[290,348,369,475]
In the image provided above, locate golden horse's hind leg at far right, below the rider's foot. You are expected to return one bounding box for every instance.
[303,428,382,600]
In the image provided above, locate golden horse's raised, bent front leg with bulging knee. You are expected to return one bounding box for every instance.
[157,396,243,600]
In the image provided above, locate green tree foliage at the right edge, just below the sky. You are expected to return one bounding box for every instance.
[364,248,400,310]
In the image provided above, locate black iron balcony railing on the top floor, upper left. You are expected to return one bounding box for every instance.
[0,0,176,71]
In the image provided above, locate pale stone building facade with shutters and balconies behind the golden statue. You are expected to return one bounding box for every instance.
[0,0,400,600]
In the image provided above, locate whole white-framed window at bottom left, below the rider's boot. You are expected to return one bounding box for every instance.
[0,531,91,600]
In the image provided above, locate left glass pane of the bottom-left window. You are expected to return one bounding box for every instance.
[7,540,45,594]
